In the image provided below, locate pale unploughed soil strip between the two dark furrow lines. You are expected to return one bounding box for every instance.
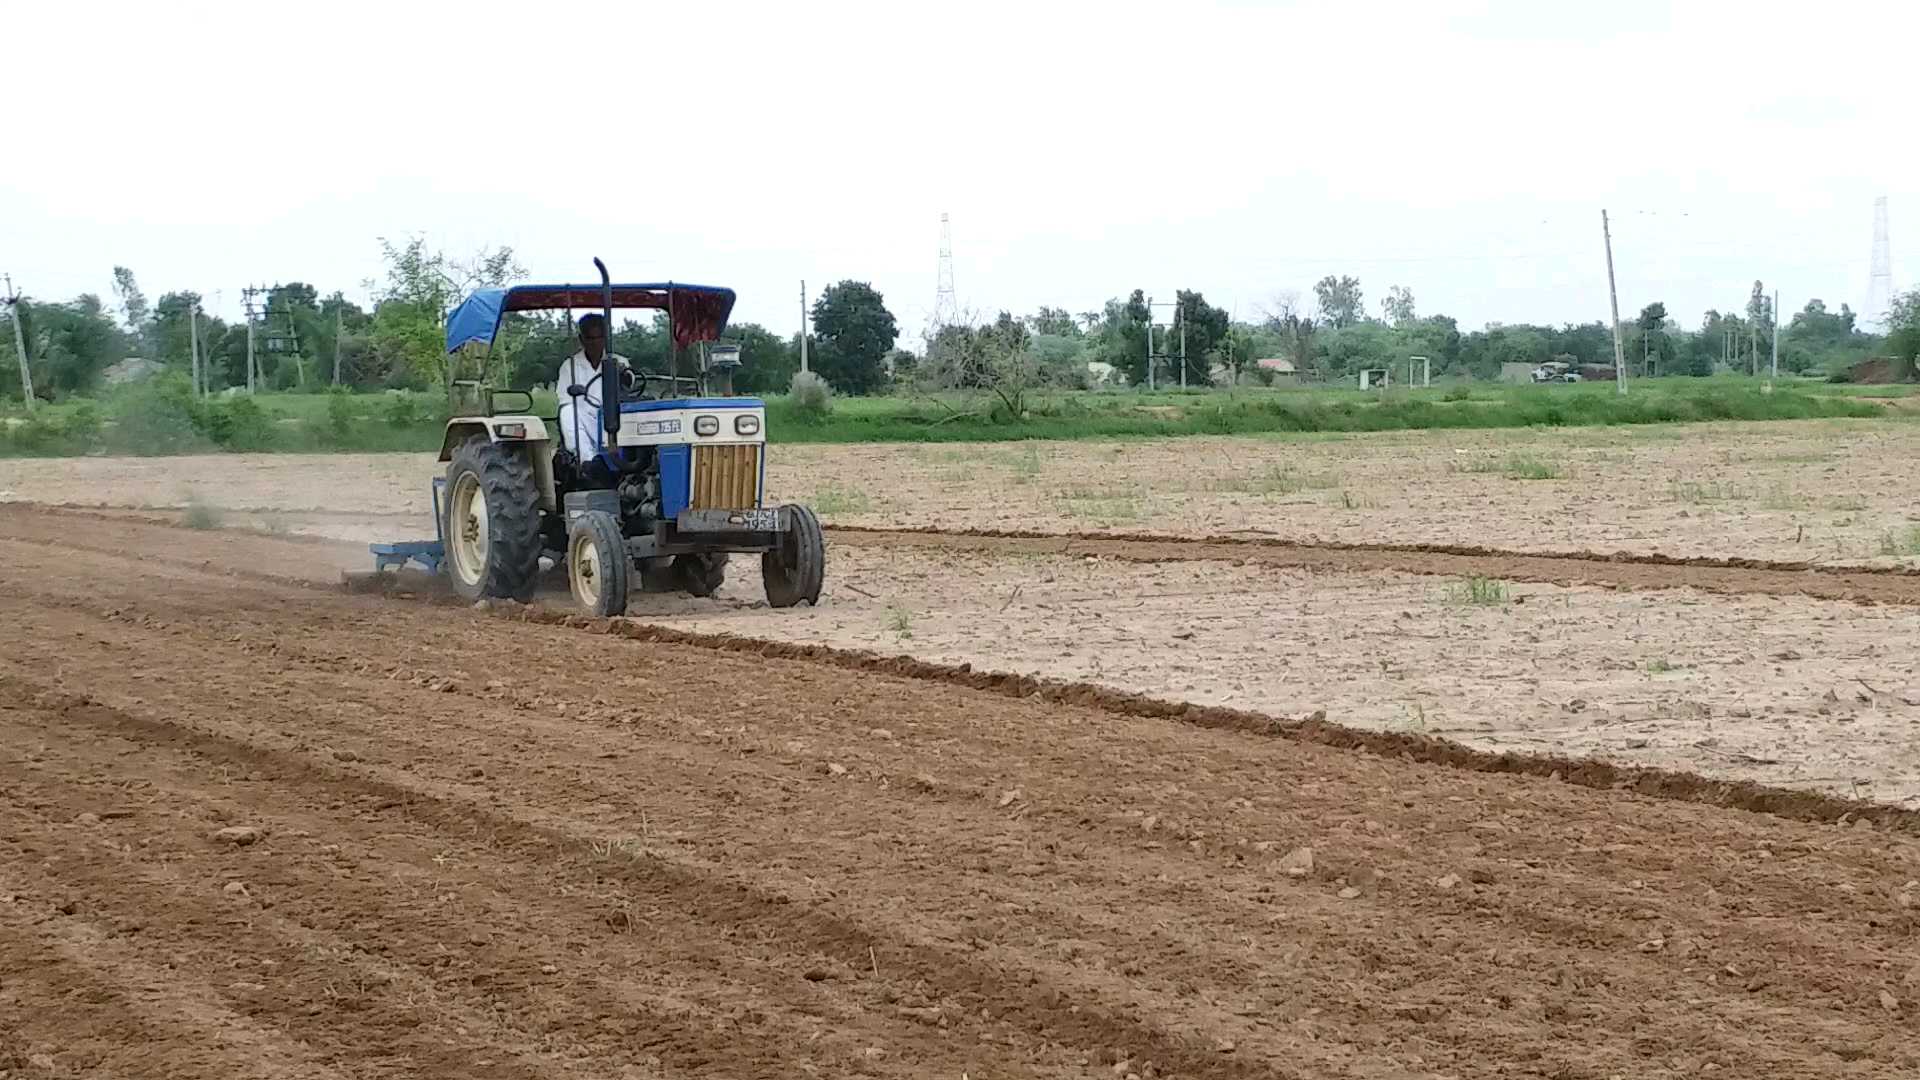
[22,507,1920,817]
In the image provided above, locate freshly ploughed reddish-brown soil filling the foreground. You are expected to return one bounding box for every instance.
[0,513,1920,1076]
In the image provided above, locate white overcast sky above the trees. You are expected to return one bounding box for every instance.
[0,0,1920,338]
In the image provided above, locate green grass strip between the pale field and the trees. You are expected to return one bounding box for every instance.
[0,377,1889,455]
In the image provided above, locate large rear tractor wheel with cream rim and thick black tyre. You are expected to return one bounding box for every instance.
[440,434,540,601]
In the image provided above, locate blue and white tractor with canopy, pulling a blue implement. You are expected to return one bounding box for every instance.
[372,259,826,617]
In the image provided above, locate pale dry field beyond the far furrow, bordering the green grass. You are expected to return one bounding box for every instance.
[11,421,1920,567]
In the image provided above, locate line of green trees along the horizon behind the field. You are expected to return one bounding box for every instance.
[0,238,1920,401]
